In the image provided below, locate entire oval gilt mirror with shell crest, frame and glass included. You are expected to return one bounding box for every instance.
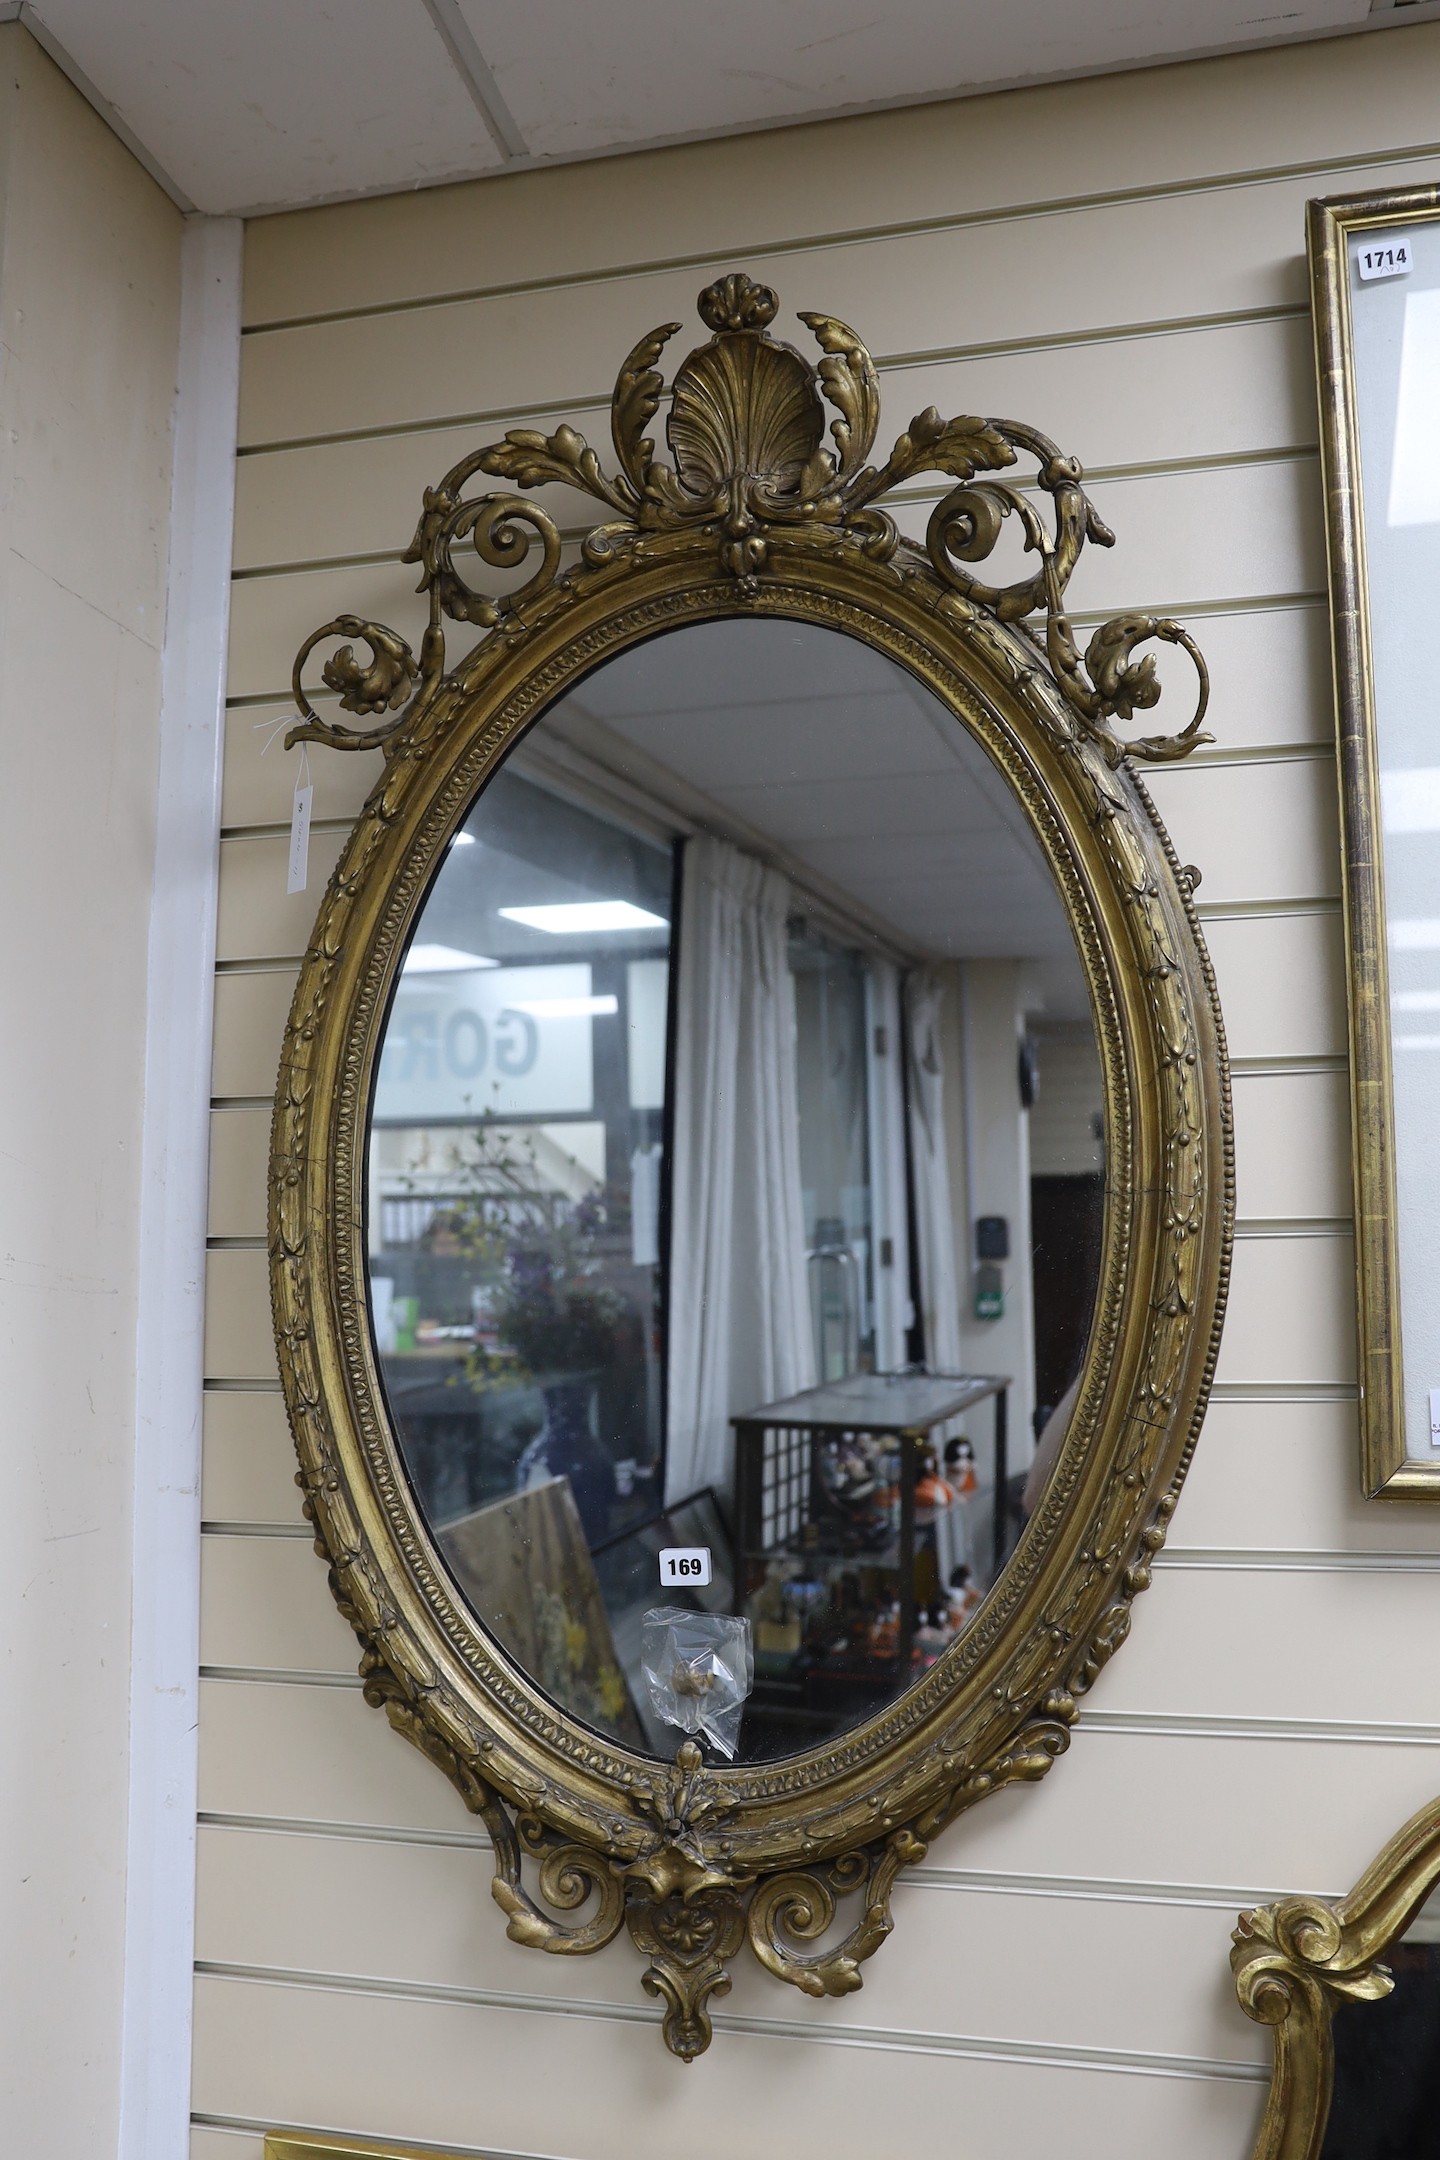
[272,276,1231,2058]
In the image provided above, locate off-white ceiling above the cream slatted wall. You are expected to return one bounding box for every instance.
[32,0,1381,212]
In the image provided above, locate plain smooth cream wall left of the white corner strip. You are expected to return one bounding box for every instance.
[0,26,181,2160]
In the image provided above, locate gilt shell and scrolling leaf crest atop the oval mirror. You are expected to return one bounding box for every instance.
[287,270,1209,762]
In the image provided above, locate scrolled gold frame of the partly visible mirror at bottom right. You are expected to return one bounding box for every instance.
[1231,1799,1440,2160]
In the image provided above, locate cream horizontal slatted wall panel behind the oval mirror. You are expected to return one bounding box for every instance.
[194,26,1440,2160]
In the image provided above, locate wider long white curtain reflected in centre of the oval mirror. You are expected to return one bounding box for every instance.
[665,836,816,1503]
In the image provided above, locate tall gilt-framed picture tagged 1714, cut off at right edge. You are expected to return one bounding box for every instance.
[1308,186,1440,1499]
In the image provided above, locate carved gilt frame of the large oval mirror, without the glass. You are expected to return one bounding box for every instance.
[270,274,1233,2061]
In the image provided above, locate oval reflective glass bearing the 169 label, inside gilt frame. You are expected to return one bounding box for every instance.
[367,618,1105,1760]
